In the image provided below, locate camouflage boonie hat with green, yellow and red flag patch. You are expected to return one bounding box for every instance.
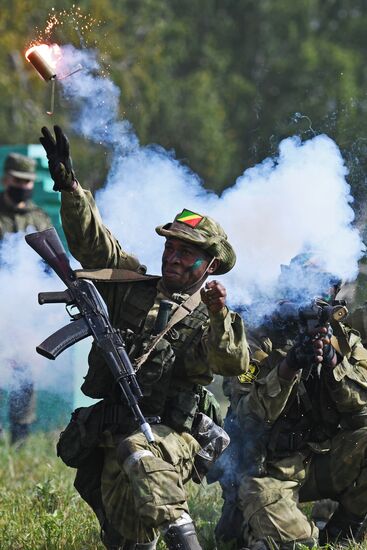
[156,209,236,275]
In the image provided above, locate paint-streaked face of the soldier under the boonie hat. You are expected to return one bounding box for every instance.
[162,238,211,291]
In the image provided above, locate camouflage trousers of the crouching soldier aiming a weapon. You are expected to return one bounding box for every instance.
[239,428,367,548]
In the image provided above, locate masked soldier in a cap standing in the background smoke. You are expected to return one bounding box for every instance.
[0,153,52,443]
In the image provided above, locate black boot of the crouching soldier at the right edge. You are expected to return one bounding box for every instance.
[319,504,365,546]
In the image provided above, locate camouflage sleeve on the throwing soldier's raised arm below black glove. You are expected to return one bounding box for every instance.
[61,185,142,271]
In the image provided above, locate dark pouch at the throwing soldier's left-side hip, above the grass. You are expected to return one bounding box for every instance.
[56,401,103,468]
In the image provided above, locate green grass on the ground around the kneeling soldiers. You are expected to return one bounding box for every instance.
[0,433,367,550]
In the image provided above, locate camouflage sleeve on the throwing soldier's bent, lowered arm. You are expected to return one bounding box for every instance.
[185,308,249,384]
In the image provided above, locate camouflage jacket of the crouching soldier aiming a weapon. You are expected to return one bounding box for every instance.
[237,323,367,455]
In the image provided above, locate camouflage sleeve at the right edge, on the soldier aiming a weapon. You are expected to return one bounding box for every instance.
[323,330,367,413]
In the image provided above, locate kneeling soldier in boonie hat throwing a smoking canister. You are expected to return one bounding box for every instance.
[41,126,248,550]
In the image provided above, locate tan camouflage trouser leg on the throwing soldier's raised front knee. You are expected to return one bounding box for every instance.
[101,425,200,542]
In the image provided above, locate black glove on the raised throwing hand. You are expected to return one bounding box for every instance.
[40,126,75,191]
